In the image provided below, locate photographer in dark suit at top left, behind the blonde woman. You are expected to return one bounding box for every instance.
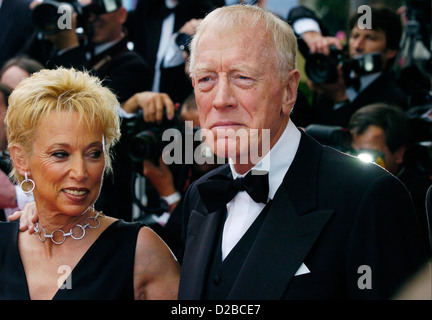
[27,0,150,103]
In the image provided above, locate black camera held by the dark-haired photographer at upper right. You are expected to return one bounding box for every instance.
[305,46,382,83]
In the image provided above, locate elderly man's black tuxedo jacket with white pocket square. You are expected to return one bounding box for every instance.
[179,133,428,300]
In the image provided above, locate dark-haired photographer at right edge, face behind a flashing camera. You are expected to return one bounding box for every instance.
[348,103,432,250]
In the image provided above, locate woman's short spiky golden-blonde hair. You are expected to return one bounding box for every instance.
[5,67,120,182]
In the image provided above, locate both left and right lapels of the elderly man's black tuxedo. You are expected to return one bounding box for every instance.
[179,132,333,300]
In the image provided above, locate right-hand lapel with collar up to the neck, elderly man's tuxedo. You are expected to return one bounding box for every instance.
[229,134,333,300]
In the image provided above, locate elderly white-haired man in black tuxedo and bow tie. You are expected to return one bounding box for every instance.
[179,5,427,299]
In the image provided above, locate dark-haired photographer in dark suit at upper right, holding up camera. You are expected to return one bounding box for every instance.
[288,6,408,127]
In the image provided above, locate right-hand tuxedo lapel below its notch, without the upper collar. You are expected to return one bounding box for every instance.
[229,186,333,300]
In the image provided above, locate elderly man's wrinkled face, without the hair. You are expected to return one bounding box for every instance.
[191,28,296,170]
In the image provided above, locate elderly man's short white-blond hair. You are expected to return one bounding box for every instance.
[189,4,297,79]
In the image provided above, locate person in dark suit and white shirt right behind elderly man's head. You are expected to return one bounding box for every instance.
[125,0,219,103]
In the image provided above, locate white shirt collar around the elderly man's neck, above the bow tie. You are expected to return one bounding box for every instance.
[228,119,301,199]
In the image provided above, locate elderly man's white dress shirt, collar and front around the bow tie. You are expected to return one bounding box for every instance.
[222,120,301,260]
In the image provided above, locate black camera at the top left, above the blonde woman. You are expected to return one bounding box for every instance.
[32,0,122,35]
